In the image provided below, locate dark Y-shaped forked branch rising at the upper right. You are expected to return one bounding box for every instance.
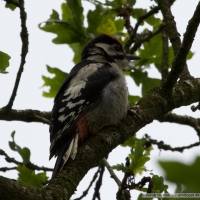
[158,0,200,92]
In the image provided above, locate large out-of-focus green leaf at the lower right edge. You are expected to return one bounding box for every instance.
[159,157,200,193]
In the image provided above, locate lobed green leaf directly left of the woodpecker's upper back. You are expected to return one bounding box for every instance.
[42,65,68,98]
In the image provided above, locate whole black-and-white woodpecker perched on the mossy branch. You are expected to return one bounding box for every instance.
[49,34,139,178]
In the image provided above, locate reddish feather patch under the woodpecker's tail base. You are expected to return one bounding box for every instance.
[76,116,89,142]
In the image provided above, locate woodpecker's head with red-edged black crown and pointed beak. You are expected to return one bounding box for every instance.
[81,34,140,70]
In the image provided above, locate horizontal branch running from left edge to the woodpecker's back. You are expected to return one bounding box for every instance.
[0,108,51,124]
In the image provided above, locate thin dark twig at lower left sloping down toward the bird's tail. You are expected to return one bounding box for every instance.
[0,149,53,171]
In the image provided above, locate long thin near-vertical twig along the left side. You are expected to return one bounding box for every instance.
[5,0,29,109]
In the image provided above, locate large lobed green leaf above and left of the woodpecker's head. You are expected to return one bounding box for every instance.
[39,0,85,44]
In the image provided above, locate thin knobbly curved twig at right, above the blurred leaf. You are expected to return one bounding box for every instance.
[145,134,200,153]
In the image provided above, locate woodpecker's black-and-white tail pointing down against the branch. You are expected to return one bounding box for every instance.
[52,133,78,178]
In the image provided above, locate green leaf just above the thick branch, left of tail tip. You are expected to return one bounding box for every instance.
[17,166,48,188]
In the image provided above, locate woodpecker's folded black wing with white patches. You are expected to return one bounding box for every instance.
[50,61,115,158]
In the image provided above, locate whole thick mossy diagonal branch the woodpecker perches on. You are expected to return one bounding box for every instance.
[0,76,200,200]
